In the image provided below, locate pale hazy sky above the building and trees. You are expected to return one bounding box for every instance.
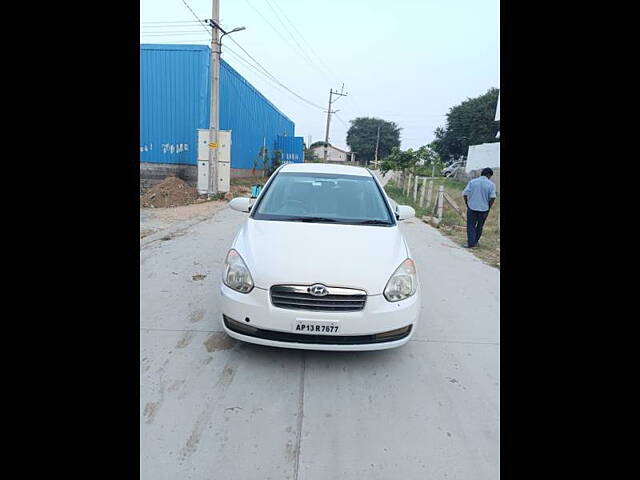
[140,0,500,149]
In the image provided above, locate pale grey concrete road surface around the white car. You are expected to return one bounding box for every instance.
[140,179,500,480]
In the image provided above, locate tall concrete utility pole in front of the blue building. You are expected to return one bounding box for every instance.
[209,0,220,195]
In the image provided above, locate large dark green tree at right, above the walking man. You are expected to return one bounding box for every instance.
[432,88,500,162]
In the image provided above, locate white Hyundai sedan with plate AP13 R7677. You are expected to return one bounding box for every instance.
[220,163,420,350]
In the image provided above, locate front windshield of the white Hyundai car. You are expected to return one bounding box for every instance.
[252,172,395,225]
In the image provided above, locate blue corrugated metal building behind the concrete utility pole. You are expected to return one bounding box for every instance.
[140,44,304,174]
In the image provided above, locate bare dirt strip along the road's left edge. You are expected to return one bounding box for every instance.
[140,200,228,239]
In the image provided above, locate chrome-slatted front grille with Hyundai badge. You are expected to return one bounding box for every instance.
[271,285,367,312]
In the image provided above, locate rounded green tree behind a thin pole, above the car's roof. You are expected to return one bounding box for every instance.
[347,117,401,165]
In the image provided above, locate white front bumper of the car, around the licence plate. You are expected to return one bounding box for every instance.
[220,284,420,351]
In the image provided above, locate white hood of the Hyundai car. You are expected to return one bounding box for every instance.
[233,218,409,295]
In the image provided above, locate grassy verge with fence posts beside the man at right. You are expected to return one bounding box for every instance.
[385,177,500,267]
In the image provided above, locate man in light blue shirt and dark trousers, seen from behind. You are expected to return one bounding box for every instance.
[462,168,496,248]
